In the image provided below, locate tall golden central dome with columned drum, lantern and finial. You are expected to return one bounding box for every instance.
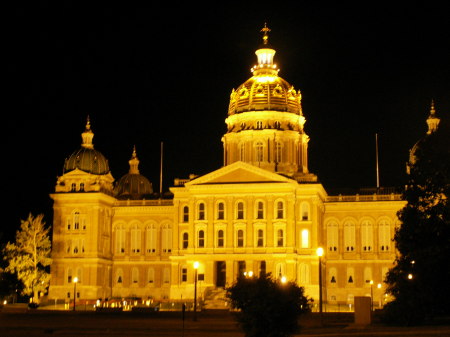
[222,26,317,181]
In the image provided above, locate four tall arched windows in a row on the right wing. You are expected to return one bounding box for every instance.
[326,221,393,252]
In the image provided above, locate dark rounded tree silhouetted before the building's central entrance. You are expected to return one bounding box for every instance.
[227,274,310,337]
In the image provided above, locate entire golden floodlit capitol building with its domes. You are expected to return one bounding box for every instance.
[49,28,428,305]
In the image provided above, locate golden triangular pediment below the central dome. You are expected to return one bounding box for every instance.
[185,161,293,186]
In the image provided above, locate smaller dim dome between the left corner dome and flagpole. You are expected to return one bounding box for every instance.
[114,149,153,200]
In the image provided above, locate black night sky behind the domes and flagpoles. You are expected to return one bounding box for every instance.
[0,1,450,241]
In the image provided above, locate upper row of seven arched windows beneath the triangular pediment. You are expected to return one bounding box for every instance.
[181,200,310,223]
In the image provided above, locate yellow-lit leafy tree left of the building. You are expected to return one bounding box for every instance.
[4,214,52,303]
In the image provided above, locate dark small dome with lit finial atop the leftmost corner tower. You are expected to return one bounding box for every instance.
[64,118,110,175]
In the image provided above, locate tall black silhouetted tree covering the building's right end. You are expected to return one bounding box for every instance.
[384,124,450,325]
